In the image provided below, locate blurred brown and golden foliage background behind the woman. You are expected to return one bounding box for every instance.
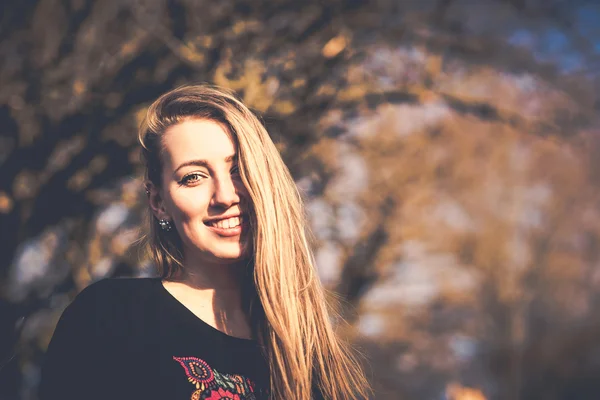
[0,0,600,400]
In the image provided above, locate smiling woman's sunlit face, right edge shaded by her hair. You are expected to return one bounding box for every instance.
[151,119,250,264]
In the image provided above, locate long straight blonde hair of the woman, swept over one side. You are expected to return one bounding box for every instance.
[139,85,370,400]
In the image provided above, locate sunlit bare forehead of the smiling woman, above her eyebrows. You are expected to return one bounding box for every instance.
[162,119,236,166]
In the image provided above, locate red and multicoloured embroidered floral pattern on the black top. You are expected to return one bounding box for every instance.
[173,357,266,400]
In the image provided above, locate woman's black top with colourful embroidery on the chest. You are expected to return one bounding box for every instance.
[40,278,269,400]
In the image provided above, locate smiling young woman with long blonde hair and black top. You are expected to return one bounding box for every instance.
[40,86,369,400]
